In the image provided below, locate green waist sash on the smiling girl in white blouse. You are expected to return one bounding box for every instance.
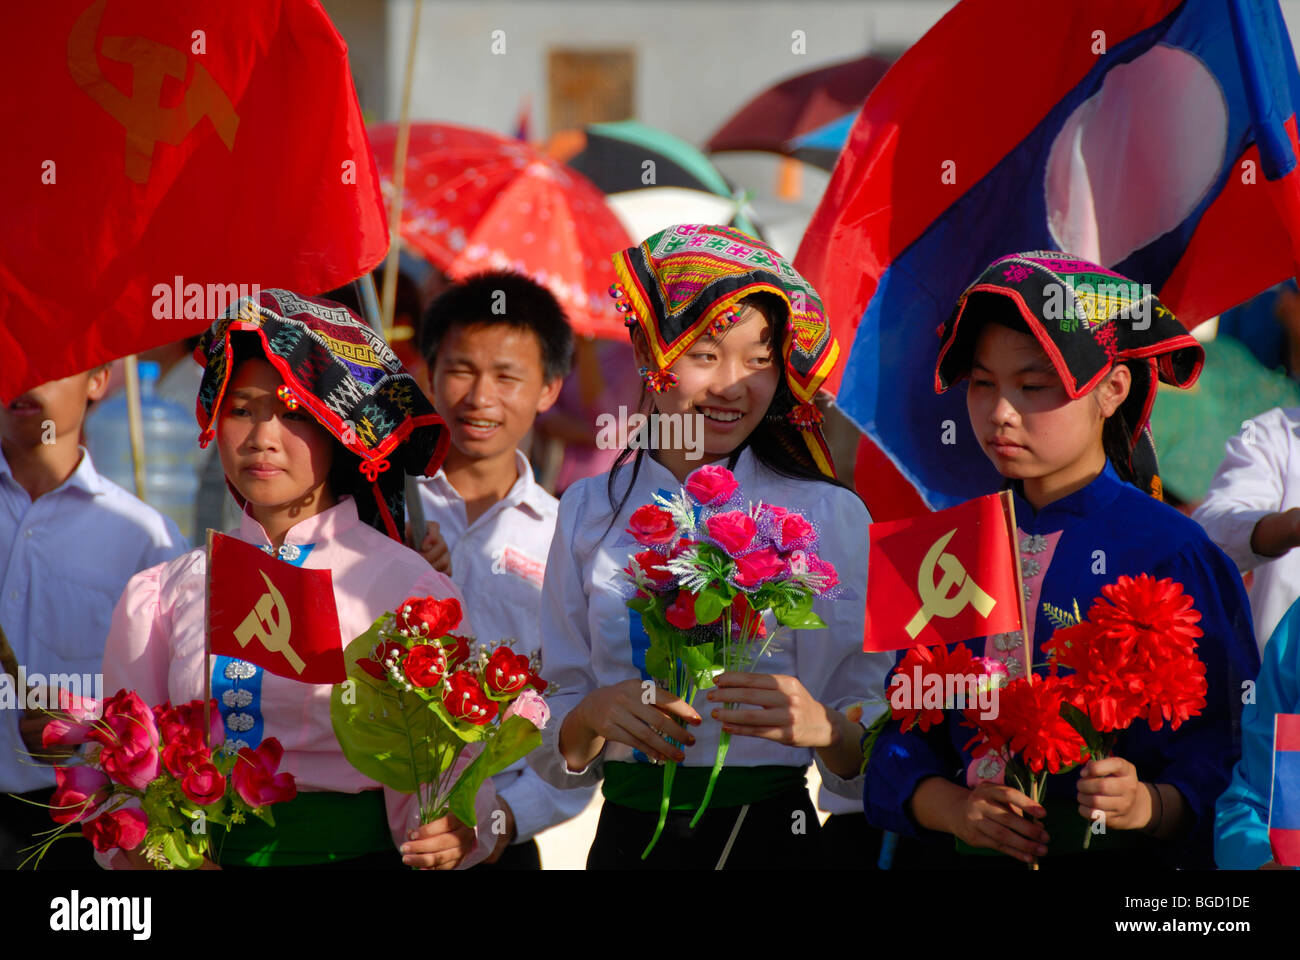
[601,762,807,813]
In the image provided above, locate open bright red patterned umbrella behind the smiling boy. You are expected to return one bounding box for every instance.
[369,124,632,340]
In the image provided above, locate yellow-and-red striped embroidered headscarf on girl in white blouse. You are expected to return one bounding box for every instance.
[610,224,840,476]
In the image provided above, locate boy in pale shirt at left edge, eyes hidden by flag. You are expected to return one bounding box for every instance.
[0,366,188,869]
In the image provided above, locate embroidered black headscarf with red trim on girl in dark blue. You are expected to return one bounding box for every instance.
[935,250,1205,497]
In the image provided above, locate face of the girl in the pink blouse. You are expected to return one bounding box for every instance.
[217,358,334,509]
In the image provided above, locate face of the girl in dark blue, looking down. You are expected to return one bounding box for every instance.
[966,323,1130,506]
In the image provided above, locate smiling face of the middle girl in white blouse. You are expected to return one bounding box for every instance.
[636,297,781,472]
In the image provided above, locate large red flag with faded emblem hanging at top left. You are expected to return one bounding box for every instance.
[0,0,387,402]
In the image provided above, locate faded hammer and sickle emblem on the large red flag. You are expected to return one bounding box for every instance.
[68,0,239,183]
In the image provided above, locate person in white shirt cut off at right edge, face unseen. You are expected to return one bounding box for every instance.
[1192,407,1300,653]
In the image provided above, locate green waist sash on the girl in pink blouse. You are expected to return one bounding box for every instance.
[212,790,398,866]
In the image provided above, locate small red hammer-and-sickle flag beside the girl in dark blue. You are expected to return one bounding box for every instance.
[863,493,1021,653]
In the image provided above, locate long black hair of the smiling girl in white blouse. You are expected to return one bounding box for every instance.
[606,293,855,533]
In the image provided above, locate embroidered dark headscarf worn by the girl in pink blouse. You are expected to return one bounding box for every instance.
[194,290,451,542]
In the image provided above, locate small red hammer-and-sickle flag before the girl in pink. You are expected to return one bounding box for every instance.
[208,533,347,683]
